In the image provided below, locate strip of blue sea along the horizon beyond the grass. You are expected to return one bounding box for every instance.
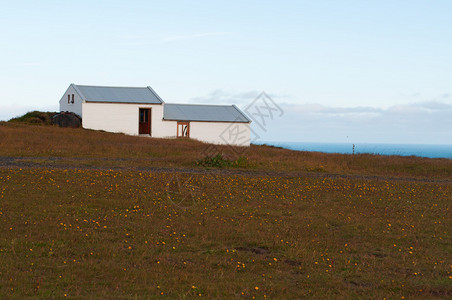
[257,142,452,159]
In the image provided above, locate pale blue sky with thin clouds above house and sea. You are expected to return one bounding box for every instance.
[0,0,452,144]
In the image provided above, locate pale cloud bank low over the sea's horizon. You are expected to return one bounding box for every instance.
[255,101,452,144]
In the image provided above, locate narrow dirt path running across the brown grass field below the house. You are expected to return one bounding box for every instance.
[0,156,452,184]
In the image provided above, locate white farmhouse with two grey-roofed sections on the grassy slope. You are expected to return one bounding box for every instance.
[60,84,251,146]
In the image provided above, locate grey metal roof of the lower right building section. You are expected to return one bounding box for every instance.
[163,103,251,123]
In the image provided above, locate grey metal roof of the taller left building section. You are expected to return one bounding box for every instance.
[72,84,164,104]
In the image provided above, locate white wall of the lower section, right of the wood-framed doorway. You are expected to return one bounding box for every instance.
[190,122,250,146]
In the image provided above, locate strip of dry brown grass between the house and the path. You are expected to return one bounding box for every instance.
[0,123,452,180]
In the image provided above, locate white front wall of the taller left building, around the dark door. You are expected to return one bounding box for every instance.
[82,102,166,137]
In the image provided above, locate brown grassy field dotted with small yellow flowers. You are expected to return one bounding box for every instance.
[0,124,452,299]
